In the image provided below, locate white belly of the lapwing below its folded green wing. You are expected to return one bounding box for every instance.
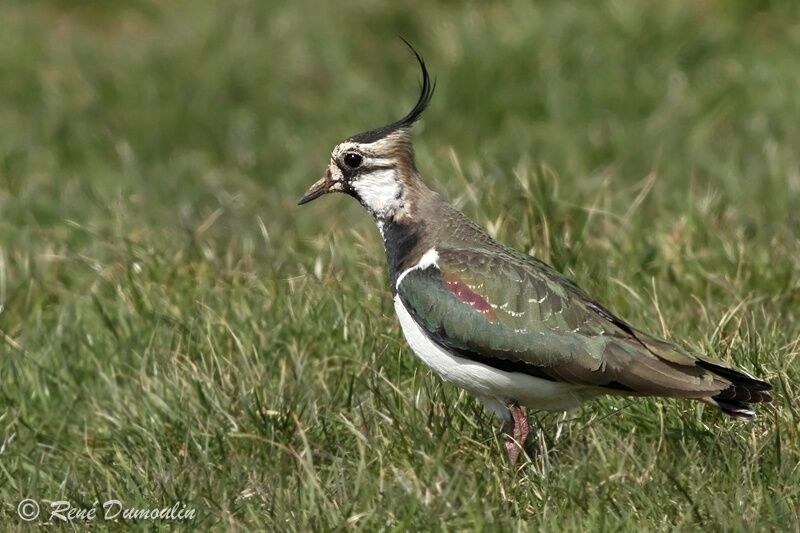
[394,296,597,411]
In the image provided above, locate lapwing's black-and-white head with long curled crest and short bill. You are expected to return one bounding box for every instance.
[298,43,434,221]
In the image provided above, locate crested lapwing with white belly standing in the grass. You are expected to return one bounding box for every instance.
[298,42,772,465]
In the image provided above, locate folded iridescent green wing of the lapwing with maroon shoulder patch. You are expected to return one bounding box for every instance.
[397,248,720,395]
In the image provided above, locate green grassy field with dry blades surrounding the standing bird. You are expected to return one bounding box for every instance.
[0,0,800,531]
